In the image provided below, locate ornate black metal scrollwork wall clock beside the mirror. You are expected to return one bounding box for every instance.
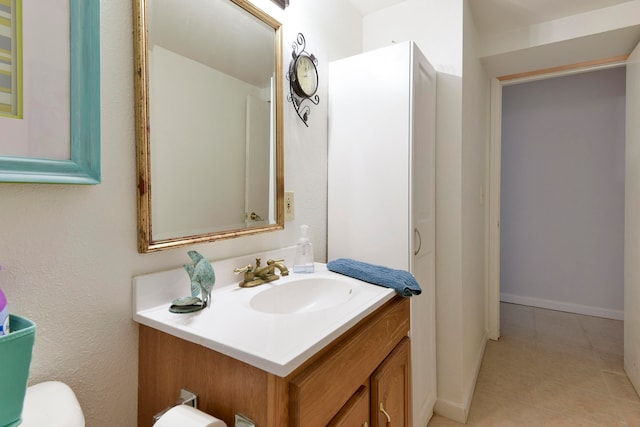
[287,33,320,127]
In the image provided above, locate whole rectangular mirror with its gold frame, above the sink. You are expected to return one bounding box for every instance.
[134,0,284,252]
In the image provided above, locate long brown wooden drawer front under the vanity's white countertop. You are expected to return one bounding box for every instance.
[289,297,409,427]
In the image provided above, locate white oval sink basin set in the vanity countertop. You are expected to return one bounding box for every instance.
[249,276,357,314]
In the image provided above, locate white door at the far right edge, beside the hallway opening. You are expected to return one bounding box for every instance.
[624,41,640,392]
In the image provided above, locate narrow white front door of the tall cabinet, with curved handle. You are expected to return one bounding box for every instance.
[409,45,437,426]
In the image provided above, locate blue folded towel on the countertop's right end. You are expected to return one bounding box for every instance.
[327,258,422,297]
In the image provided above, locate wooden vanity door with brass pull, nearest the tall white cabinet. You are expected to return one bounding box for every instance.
[371,337,411,427]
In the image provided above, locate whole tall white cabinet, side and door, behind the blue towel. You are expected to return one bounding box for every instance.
[327,42,436,427]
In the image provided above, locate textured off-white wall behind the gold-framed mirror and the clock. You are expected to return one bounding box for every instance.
[0,0,362,427]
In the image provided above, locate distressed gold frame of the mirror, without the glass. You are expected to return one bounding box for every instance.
[133,0,284,253]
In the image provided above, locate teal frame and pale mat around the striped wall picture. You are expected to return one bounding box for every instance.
[0,0,101,184]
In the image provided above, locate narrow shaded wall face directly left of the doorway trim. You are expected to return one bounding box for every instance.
[462,2,490,414]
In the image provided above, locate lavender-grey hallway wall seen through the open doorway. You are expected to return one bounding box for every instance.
[500,67,625,319]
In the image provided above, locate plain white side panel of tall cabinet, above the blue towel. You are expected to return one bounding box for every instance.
[327,42,412,270]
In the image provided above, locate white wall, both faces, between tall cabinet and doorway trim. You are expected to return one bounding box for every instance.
[363,0,489,421]
